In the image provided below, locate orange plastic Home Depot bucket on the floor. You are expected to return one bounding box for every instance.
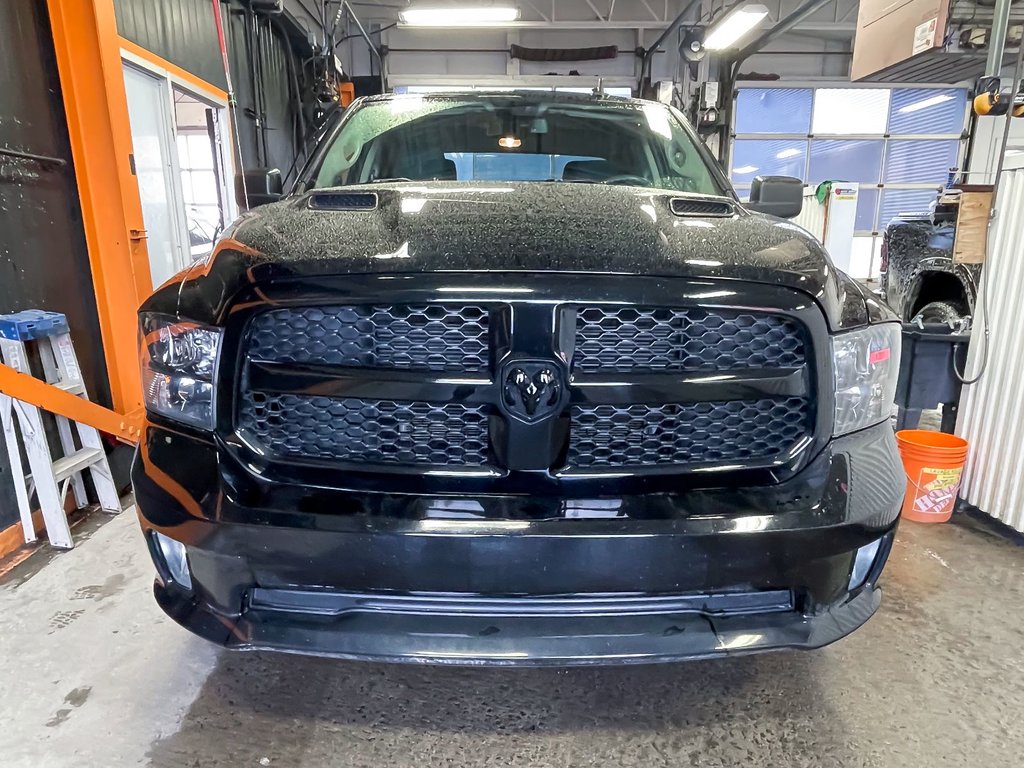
[896,429,968,522]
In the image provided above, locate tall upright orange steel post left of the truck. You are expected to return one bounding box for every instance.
[47,0,153,415]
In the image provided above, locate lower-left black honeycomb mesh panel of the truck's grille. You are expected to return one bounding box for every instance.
[239,392,488,466]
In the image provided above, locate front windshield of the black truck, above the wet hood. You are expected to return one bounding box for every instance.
[311,94,723,195]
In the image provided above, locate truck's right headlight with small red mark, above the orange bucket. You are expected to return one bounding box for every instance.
[831,323,902,436]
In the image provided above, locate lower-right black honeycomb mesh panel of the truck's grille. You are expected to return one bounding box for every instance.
[568,397,810,468]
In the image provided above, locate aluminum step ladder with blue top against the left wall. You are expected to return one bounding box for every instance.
[0,309,121,549]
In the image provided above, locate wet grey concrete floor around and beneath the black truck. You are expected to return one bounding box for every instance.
[0,512,1024,768]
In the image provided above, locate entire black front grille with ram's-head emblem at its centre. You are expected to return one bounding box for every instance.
[232,275,823,490]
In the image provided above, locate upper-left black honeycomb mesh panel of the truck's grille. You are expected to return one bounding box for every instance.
[249,304,487,372]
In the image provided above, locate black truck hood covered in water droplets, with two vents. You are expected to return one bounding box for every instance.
[159,182,884,328]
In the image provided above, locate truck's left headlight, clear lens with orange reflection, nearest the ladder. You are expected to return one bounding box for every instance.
[139,312,221,429]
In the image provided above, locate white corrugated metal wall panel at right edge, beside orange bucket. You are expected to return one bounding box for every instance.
[956,170,1024,531]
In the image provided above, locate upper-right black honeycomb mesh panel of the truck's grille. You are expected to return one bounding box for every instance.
[572,306,805,373]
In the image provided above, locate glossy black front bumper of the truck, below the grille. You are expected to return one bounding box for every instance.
[132,424,903,665]
